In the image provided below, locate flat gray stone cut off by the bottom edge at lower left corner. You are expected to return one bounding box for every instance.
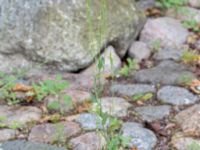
[0,140,66,150]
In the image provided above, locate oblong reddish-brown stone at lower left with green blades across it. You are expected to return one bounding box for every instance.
[28,122,81,143]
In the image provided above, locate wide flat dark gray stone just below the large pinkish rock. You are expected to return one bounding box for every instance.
[133,61,195,85]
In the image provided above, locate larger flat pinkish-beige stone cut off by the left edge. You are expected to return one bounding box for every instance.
[0,105,42,128]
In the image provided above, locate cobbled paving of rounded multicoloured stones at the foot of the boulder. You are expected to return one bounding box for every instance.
[0,0,200,150]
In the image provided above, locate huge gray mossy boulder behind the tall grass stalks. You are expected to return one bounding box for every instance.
[0,0,145,71]
